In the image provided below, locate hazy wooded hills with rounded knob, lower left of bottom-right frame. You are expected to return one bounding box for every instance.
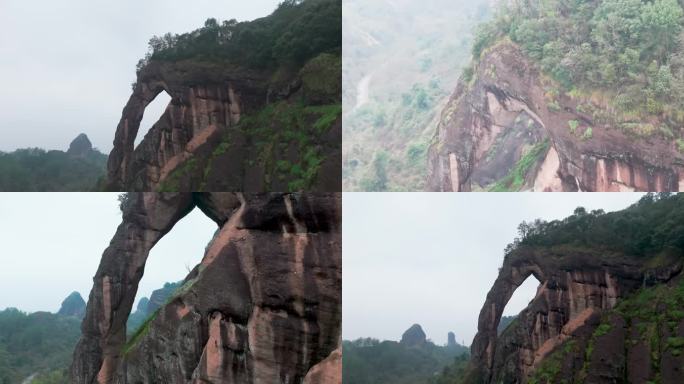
[342,324,468,384]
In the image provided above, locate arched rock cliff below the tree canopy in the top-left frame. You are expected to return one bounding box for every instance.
[106,54,341,192]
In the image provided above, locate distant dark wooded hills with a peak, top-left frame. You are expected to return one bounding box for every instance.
[0,134,107,192]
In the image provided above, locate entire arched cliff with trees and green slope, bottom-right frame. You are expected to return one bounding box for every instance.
[461,196,684,384]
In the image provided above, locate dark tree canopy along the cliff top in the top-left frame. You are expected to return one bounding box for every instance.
[138,0,342,70]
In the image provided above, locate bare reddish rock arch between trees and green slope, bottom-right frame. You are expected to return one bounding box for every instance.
[469,246,660,383]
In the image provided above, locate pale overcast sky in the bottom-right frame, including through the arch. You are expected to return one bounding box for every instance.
[342,193,641,345]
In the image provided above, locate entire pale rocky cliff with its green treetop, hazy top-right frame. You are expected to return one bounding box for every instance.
[426,0,684,192]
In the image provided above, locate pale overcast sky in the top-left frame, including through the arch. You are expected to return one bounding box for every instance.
[0,0,280,153]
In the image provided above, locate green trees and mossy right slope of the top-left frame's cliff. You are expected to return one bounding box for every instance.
[138,0,342,192]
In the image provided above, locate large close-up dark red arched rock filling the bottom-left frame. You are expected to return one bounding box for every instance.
[71,193,342,384]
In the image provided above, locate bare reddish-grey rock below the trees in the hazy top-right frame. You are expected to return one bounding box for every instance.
[427,42,684,191]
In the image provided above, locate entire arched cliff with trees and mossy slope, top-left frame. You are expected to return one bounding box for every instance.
[104,0,341,192]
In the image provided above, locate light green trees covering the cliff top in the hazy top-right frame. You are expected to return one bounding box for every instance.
[470,0,684,140]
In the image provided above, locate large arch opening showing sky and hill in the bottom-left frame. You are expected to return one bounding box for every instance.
[126,208,218,334]
